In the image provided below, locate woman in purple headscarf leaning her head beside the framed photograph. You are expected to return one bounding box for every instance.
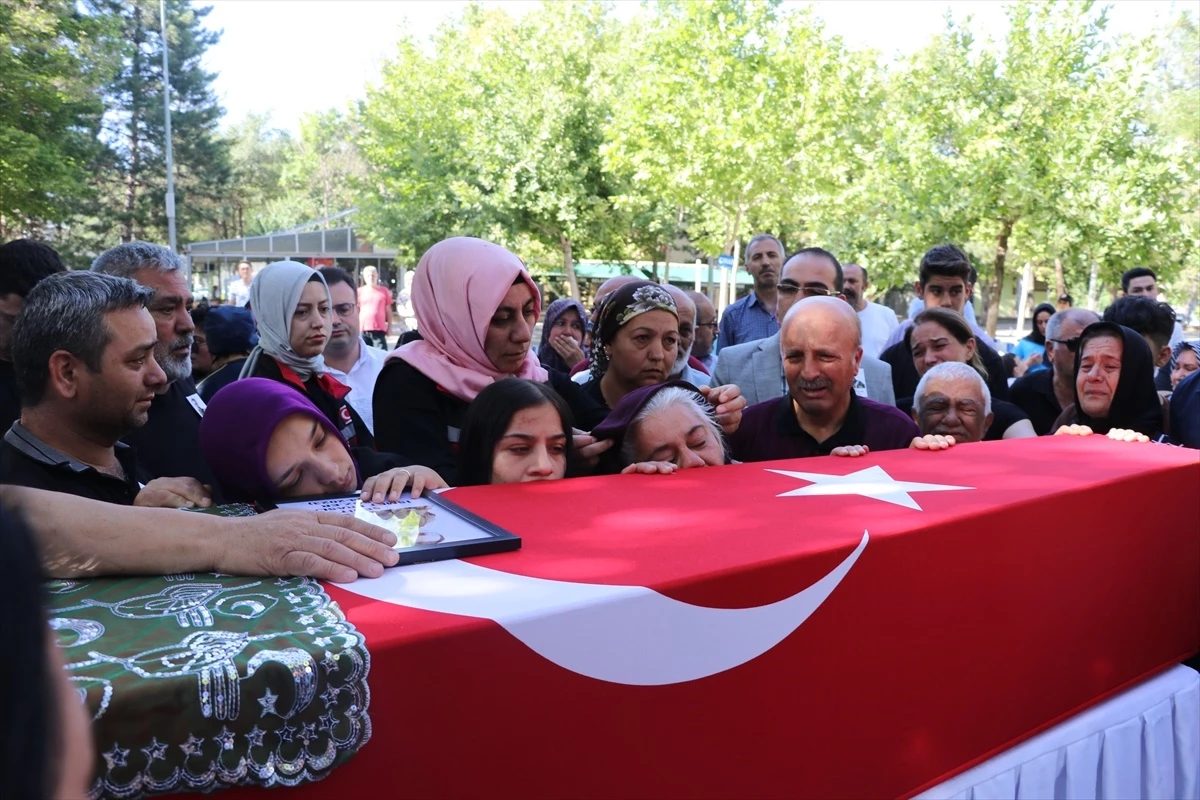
[200,378,446,503]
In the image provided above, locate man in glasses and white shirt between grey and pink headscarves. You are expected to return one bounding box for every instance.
[318,266,388,434]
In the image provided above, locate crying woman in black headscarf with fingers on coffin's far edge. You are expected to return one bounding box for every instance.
[1051,323,1166,439]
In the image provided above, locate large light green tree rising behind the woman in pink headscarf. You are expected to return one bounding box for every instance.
[360,4,616,297]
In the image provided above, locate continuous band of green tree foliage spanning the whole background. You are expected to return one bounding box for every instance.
[0,0,1200,316]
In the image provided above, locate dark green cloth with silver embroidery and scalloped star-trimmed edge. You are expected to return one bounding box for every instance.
[48,512,371,798]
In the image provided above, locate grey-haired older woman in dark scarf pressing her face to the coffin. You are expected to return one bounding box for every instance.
[592,380,730,473]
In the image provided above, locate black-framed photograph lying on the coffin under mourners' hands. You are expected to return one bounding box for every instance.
[275,492,521,566]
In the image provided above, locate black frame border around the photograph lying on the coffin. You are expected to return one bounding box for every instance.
[271,492,521,566]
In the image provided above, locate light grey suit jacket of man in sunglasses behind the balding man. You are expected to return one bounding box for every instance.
[713,333,896,405]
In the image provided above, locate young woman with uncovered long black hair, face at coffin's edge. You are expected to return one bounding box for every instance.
[458,378,576,486]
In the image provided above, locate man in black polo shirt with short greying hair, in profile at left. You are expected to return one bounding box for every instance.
[0,272,206,505]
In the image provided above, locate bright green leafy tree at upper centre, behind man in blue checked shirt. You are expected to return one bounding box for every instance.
[604,0,870,272]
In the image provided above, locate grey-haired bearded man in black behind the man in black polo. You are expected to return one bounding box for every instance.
[91,241,214,496]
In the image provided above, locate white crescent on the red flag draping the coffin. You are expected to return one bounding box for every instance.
[341,531,870,686]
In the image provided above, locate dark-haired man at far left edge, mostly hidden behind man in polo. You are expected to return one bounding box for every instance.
[0,239,67,431]
